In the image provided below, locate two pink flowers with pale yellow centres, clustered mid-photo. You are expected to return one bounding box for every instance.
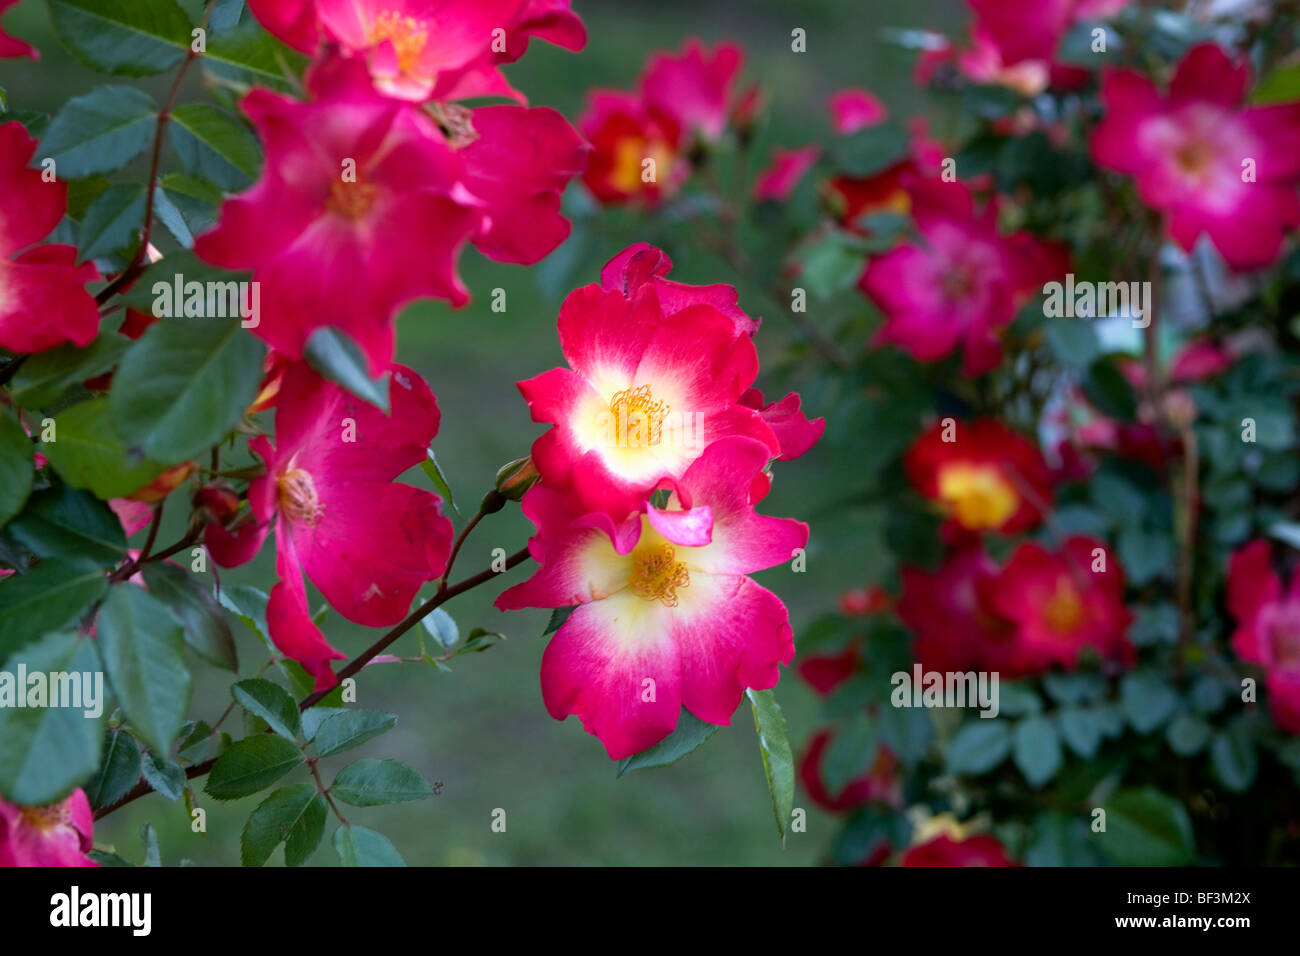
[497,243,824,758]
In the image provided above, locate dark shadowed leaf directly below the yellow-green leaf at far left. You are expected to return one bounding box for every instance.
[9,483,126,567]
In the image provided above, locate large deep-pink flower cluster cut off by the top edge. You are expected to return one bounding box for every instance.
[195,0,588,375]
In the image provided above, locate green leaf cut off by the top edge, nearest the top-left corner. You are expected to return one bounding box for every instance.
[47,0,191,77]
